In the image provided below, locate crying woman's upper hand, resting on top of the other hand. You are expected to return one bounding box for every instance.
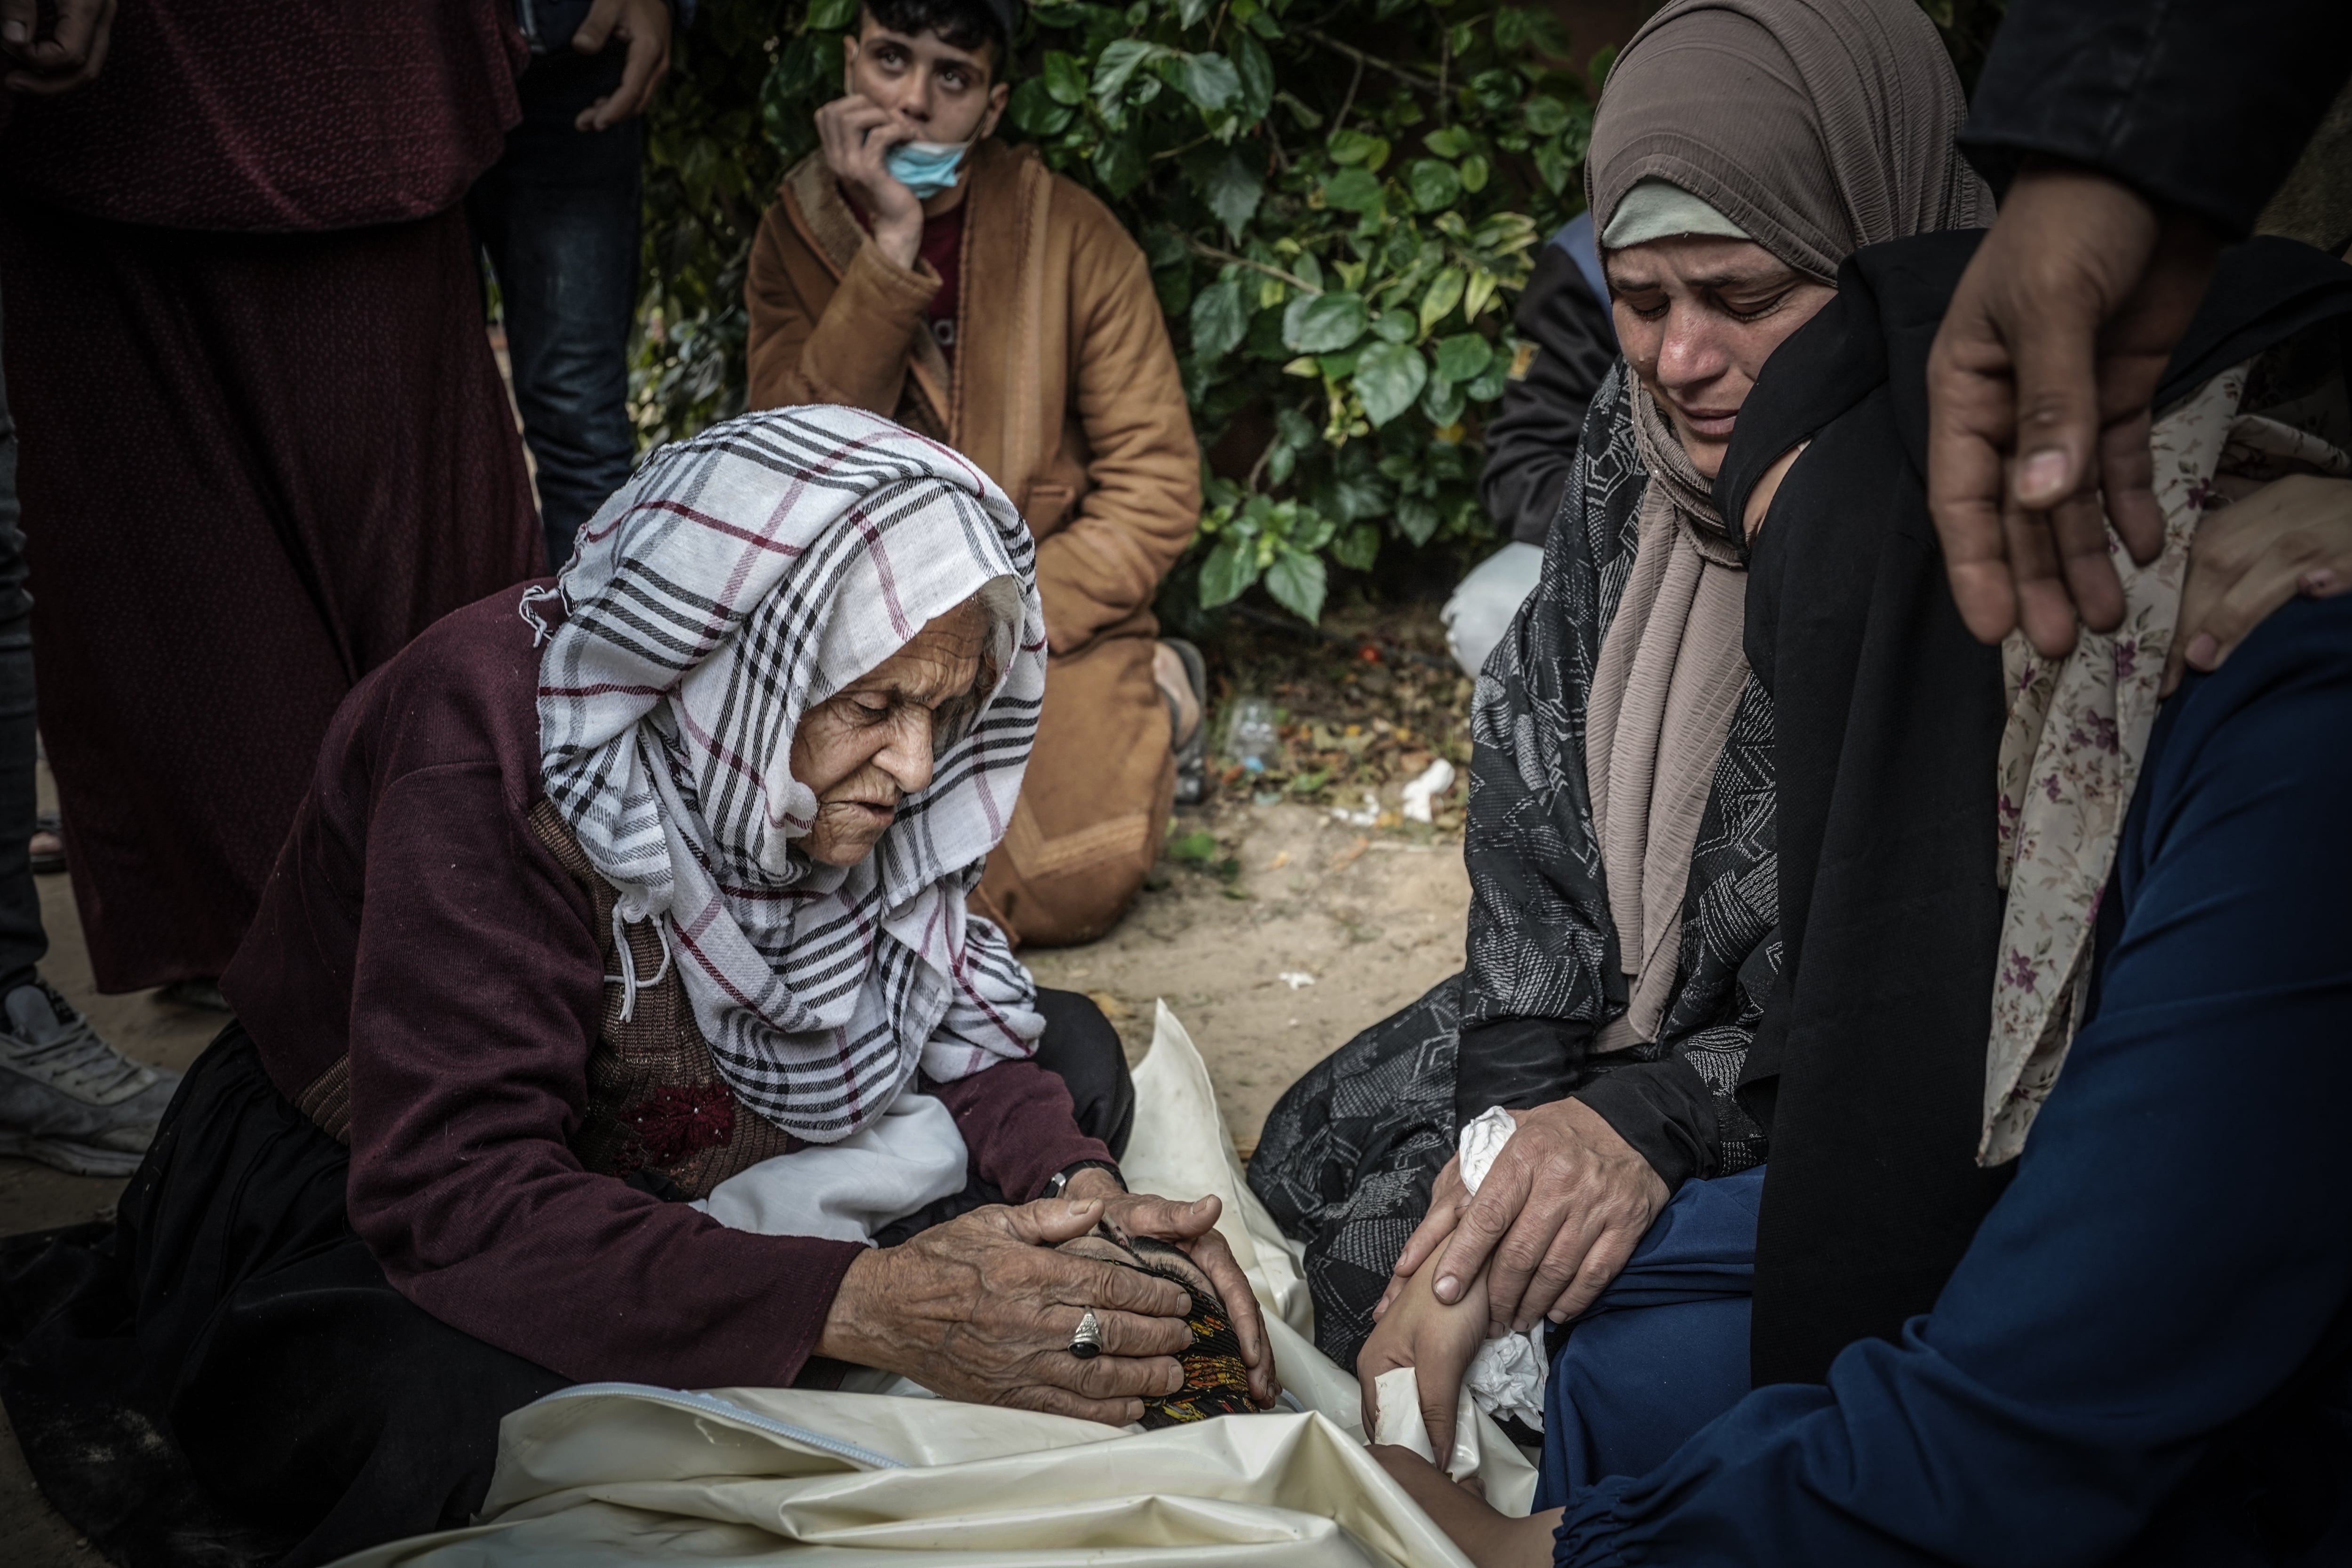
[1421,1100,1670,1333]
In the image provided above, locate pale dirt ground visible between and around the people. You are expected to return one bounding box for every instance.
[0,609,1470,1568]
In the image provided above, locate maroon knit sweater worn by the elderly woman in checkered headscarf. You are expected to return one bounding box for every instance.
[221,588,1110,1387]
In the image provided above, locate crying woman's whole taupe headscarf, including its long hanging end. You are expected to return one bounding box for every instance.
[1585,0,1992,1051]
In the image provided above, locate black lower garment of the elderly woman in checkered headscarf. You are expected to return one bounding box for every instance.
[0,992,1134,1568]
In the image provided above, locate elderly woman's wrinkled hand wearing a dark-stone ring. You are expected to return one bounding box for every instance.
[816,1199,1192,1427]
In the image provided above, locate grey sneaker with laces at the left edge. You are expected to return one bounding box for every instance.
[0,980,179,1176]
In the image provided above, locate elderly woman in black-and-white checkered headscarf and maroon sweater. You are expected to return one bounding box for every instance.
[0,409,1272,1563]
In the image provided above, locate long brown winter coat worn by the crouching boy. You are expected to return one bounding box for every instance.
[743,139,1200,943]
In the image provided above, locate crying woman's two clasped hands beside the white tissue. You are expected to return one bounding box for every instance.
[1355,1100,1670,1455]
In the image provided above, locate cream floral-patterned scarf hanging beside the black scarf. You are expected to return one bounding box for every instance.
[1976,365,2352,1166]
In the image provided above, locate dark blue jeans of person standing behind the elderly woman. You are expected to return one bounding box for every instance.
[466,42,644,571]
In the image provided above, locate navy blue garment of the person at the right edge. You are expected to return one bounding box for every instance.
[1555,597,2352,1568]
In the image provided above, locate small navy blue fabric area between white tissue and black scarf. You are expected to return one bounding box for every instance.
[1536,1166,1764,1509]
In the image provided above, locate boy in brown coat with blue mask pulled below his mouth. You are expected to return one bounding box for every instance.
[743,0,1202,945]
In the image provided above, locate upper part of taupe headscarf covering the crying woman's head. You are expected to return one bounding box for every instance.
[1585,0,1992,282]
